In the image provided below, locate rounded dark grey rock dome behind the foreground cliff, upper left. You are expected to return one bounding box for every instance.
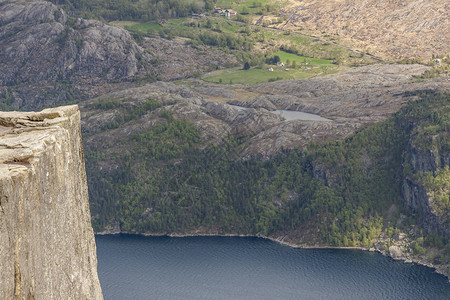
[0,0,148,109]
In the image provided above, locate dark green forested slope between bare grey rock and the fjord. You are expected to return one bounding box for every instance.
[86,93,449,252]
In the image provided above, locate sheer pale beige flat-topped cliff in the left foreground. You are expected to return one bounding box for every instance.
[0,106,103,299]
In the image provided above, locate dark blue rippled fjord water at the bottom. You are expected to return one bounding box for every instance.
[96,235,450,300]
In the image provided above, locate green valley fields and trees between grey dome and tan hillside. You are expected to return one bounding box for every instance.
[54,0,371,84]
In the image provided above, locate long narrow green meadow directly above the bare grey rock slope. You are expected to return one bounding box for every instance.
[203,66,338,84]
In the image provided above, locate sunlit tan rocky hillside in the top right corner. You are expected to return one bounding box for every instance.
[280,0,450,60]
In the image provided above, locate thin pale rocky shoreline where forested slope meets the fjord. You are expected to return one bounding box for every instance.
[94,231,450,283]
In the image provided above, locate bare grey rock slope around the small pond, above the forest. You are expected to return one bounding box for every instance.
[82,65,444,158]
